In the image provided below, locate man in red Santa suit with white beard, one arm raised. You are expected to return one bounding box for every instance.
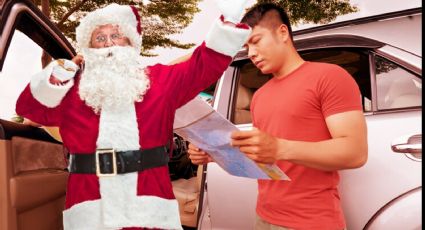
[16,0,250,230]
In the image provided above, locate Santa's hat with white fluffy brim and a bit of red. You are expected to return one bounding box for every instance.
[75,3,142,51]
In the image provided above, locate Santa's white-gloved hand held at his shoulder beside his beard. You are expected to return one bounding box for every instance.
[49,55,84,85]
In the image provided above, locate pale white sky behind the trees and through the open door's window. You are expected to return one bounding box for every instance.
[0,0,422,120]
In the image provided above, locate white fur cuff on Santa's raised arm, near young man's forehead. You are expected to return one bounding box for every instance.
[205,19,251,57]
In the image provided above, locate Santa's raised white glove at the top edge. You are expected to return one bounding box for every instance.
[217,0,248,24]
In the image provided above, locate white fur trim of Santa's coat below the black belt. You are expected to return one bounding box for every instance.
[63,172,182,230]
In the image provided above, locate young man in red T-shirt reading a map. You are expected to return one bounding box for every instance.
[189,4,367,230]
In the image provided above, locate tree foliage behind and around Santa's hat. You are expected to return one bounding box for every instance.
[35,0,201,56]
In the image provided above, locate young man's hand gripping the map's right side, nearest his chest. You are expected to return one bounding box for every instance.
[231,128,280,164]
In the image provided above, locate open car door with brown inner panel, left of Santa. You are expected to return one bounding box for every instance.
[0,0,75,230]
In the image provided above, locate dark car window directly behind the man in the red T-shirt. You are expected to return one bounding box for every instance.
[231,48,372,124]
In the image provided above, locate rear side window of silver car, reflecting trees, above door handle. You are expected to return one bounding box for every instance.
[375,56,422,110]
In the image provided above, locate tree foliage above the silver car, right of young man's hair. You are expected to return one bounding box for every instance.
[253,0,358,25]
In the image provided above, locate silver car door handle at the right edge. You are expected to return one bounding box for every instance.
[391,134,422,161]
